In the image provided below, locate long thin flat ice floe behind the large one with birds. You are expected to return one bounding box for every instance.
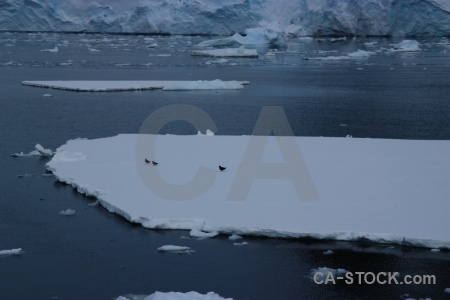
[22,79,247,92]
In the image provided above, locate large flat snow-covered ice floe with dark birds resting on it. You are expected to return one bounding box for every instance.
[46,134,450,248]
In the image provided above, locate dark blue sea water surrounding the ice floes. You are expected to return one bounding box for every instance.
[0,33,450,299]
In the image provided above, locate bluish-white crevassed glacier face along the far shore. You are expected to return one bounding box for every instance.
[0,0,450,36]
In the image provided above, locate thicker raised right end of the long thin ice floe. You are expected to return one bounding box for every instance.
[163,79,243,91]
